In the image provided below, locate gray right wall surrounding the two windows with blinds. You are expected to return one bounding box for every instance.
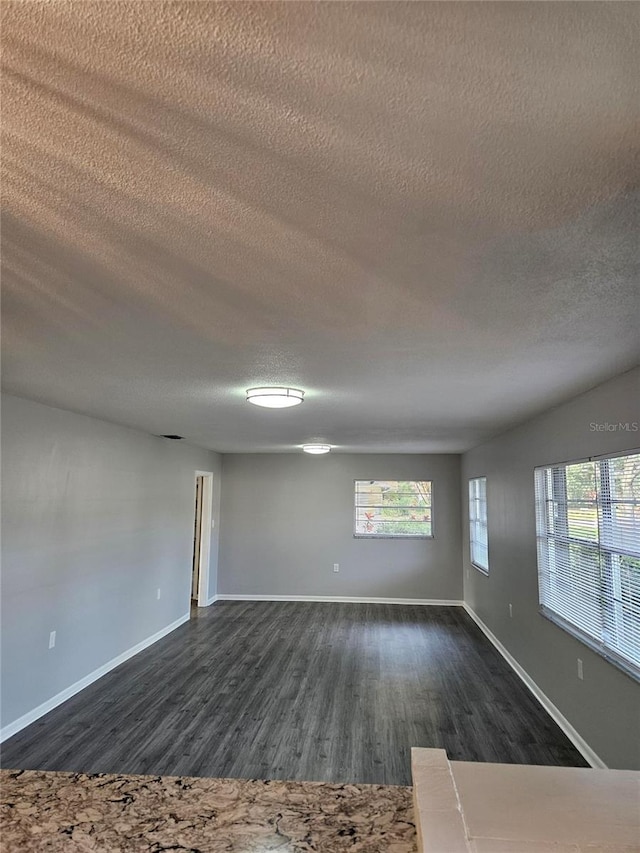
[462,370,640,769]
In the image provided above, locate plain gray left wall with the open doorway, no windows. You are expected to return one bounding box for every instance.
[1,395,220,725]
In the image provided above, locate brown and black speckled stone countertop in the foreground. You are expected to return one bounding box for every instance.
[0,770,416,853]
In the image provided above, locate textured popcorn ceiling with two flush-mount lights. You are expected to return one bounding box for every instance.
[2,0,640,452]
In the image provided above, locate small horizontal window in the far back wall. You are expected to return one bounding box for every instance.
[353,480,433,538]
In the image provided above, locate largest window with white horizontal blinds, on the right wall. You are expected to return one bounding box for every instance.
[535,452,640,679]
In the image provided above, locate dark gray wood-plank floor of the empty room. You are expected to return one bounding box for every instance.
[2,602,587,785]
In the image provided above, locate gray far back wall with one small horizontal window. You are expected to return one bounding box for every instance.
[218,453,462,599]
